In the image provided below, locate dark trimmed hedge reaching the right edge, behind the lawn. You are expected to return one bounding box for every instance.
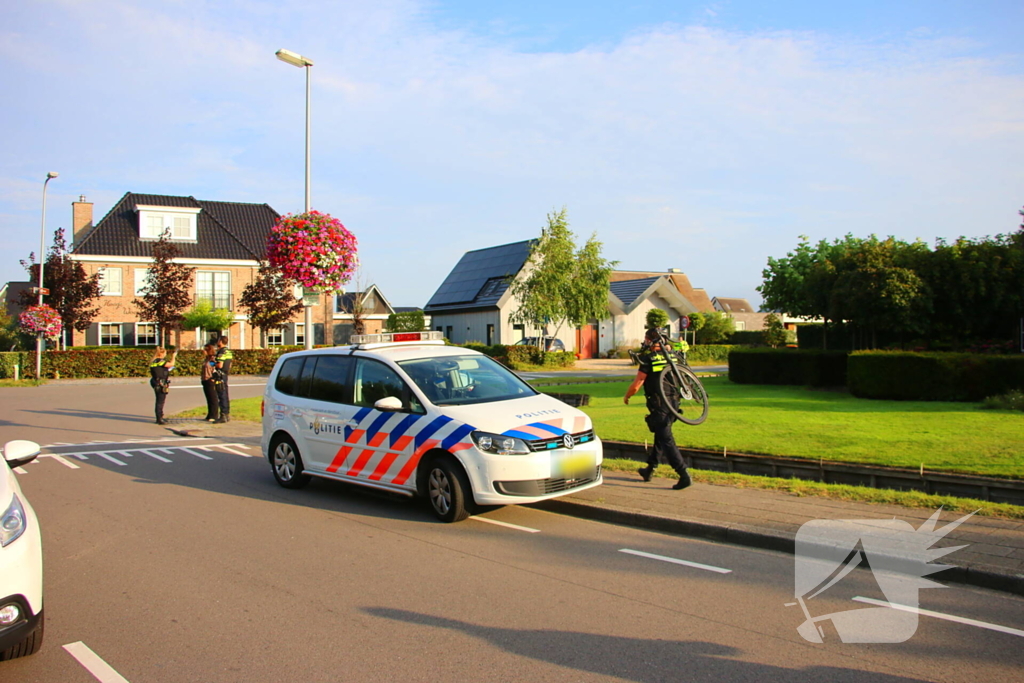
[847,351,1024,401]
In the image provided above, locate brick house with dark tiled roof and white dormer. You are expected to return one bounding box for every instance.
[65,193,393,349]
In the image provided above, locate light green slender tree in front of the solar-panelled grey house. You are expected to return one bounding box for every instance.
[509,207,615,337]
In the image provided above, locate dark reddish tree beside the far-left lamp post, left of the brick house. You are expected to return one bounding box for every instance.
[18,227,101,346]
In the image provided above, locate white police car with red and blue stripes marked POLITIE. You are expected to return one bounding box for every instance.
[262,332,602,522]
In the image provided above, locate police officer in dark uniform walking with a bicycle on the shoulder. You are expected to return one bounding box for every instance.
[623,330,691,490]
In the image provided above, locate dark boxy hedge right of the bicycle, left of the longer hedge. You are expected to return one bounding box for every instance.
[729,348,847,386]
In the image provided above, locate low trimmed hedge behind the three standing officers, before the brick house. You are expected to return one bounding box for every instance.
[0,348,281,379]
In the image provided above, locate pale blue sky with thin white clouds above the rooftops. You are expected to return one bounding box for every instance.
[0,0,1024,306]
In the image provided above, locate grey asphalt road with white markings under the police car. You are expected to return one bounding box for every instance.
[0,384,1024,683]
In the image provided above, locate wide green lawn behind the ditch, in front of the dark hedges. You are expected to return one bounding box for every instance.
[565,377,1024,477]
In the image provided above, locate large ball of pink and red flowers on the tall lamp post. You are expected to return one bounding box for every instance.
[266,211,359,292]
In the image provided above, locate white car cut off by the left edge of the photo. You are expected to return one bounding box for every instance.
[0,440,43,661]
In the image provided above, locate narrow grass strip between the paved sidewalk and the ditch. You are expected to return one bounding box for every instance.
[602,459,1024,519]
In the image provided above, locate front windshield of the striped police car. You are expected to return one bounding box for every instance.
[398,355,537,405]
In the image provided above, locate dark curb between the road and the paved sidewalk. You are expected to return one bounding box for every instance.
[529,499,1024,596]
